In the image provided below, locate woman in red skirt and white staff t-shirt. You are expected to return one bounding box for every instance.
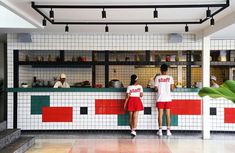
[124,74,144,136]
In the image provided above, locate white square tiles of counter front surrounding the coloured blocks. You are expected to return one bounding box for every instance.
[18,92,202,130]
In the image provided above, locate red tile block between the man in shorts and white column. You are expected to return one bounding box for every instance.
[171,99,201,115]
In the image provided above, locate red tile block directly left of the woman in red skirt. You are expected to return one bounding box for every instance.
[95,99,125,115]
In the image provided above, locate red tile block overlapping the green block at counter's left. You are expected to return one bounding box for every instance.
[42,107,73,122]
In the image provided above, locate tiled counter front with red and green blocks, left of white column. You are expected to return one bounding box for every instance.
[9,89,206,130]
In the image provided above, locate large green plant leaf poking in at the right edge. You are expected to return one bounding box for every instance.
[198,80,235,103]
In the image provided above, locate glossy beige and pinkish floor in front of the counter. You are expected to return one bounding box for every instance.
[27,138,235,153]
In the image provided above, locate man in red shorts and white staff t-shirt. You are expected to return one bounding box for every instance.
[155,64,174,136]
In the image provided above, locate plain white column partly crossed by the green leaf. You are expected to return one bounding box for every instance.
[202,36,210,139]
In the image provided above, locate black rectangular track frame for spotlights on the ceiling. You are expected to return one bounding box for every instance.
[32,0,230,25]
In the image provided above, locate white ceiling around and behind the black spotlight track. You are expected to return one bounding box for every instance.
[0,0,235,38]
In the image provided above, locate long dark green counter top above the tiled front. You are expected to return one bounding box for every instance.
[7,88,199,92]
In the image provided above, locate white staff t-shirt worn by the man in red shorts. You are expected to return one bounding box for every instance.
[155,75,174,102]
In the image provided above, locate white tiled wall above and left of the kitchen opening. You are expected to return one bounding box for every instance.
[7,33,235,127]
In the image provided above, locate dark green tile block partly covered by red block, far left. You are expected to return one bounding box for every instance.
[31,96,50,115]
